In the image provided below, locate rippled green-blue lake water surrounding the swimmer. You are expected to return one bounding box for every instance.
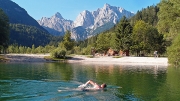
[0,63,180,101]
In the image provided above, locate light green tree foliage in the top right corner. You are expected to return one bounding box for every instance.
[157,0,180,42]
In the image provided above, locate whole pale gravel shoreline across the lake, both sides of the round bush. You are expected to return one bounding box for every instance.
[5,54,168,66]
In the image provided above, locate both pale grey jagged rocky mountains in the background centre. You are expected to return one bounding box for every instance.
[38,4,134,40]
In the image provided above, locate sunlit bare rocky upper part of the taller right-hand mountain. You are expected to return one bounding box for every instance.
[74,4,134,29]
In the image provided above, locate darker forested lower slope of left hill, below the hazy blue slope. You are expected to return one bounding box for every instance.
[10,24,53,47]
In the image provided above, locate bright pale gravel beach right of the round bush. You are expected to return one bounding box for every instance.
[68,56,168,66]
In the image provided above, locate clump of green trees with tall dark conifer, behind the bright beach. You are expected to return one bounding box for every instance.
[90,17,166,55]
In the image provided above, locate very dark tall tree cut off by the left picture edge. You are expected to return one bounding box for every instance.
[0,9,9,51]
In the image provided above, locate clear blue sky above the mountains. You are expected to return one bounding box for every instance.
[12,0,160,21]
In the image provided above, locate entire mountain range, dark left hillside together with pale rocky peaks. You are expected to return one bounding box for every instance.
[0,0,134,46]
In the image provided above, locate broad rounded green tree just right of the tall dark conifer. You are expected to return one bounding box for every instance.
[131,20,166,55]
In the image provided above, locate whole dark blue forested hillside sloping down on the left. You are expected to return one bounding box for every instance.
[0,0,53,47]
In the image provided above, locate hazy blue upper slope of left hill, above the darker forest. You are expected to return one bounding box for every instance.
[0,0,47,31]
